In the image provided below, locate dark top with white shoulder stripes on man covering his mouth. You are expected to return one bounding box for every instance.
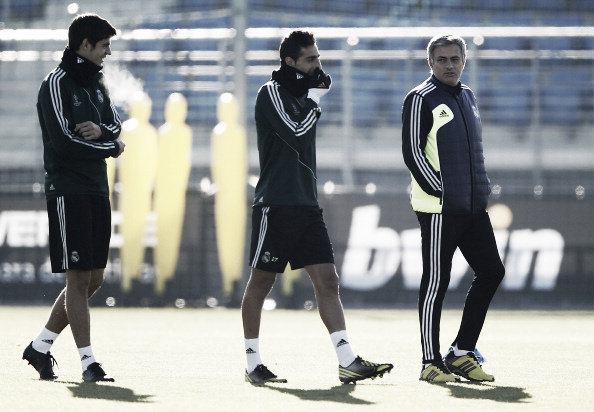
[253,65,321,206]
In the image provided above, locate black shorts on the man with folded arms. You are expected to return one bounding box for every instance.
[47,195,111,273]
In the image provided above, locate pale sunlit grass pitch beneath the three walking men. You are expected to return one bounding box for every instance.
[0,306,594,412]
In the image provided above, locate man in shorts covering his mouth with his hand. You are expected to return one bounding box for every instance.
[242,30,393,384]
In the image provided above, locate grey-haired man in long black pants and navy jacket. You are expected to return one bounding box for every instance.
[402,35,505,382]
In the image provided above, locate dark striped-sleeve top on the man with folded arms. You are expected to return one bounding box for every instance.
[37,49,121,199]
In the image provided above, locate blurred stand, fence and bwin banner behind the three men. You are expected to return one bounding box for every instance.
[0,0,594,308]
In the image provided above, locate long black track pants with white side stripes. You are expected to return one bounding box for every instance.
[417,212,505,363]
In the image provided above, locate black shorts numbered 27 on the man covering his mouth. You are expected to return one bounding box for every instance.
[250,206,334,273]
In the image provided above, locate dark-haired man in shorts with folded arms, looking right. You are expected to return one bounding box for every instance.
[23,14,124,382]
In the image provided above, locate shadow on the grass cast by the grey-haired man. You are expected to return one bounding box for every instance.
[444,382,532,403]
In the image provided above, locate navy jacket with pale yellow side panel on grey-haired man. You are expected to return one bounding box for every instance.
[402,76,490,214]
